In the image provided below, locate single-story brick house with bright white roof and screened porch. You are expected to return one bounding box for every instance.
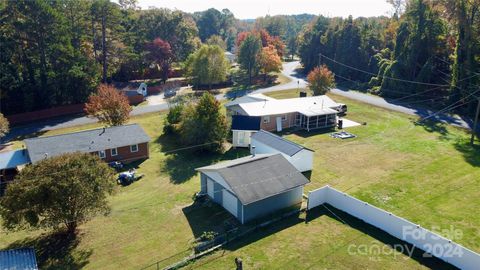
[226,95,339,131]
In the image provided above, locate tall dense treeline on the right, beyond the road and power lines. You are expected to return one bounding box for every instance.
[298,0,480,113]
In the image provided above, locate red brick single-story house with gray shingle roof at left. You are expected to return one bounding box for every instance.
[24,124,150,164]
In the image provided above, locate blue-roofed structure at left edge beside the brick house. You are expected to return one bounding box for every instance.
[0,149,30,194]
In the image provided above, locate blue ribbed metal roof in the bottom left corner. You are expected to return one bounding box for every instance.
[0,248,38,270]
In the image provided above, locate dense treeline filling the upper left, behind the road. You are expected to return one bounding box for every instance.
[0,0,314,115]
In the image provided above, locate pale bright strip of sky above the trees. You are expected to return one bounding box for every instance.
[132,0,392,19]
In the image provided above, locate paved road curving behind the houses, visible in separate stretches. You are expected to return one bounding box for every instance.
[5,61,472,140]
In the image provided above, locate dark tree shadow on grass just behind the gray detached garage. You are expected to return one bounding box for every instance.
[157,134,249,184]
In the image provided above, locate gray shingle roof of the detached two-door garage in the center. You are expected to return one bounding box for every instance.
[197,154,309,205]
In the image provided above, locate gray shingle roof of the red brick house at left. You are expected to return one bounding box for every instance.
[24,124,150,163]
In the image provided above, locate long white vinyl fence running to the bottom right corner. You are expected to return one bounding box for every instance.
[307,186,480,269]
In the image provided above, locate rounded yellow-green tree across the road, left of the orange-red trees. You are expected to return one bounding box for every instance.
[186,45,230,89]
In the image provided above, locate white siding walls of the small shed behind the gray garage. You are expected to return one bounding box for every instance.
[250,139,313,172]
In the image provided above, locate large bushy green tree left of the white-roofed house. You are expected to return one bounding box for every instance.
[179,92,228,151]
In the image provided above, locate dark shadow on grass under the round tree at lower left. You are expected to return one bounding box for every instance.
[6,231,92,269]
